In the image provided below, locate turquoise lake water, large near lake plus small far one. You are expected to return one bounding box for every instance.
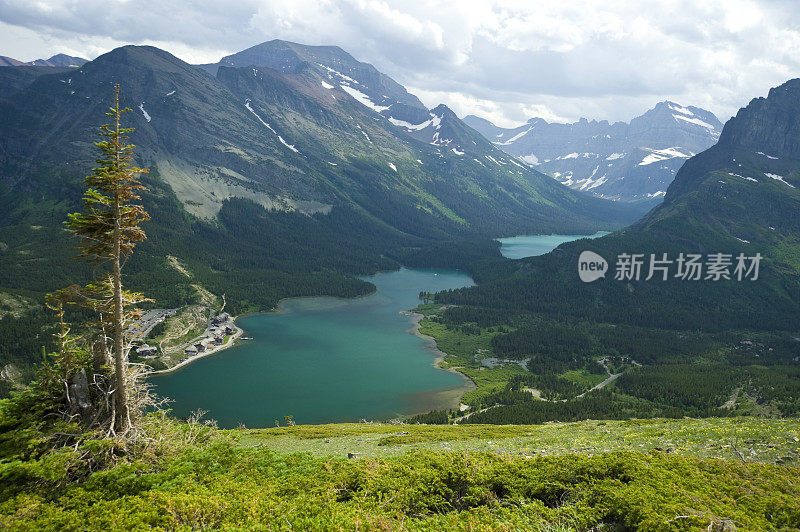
[150,235,599,428]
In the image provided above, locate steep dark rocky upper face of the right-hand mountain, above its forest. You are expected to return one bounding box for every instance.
[652,79,800,214]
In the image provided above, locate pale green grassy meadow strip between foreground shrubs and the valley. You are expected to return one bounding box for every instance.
[235,418,800,463]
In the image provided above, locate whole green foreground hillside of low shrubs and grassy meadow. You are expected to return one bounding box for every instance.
[0,419,800,530]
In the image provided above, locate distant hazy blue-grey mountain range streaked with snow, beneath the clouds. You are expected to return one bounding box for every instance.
[464,101,722,201]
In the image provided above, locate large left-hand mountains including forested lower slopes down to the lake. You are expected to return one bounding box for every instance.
[0,41,644,374]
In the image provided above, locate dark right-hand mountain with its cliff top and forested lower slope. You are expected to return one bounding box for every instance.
[444,79,800,334]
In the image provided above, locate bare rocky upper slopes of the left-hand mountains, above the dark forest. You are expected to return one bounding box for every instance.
[1,41,631,237]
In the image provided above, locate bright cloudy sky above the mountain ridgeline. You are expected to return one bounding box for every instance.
[0,0,800,126]
